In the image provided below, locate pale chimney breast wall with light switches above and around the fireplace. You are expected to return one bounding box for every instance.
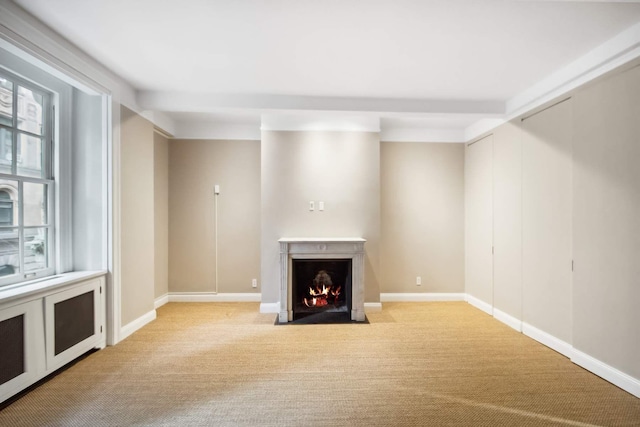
[261,131,380,303]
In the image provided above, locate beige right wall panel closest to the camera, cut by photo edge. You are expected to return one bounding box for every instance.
[573,63,640,379]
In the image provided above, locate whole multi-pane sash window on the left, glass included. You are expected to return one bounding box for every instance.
[0,70,54,286]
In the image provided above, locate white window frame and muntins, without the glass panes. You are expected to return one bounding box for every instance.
[0,67,57,289]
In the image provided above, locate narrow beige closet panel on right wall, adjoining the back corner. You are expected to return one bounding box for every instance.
[465,135,493,313]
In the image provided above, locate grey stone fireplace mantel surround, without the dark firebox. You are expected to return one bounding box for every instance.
[278,237,366,323]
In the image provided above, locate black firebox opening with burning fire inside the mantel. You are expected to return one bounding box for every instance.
[291,259,351,320]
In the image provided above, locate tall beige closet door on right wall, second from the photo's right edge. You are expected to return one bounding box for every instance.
[522,99,572,354]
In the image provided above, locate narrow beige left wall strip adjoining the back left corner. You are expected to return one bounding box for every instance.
[153,132,169,298]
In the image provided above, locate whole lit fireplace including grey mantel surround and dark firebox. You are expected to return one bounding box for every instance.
[278,238,366,323]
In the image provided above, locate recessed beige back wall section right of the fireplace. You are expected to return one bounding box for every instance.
[380,142,464,293]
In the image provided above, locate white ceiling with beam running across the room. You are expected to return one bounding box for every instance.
[11,0,640,139]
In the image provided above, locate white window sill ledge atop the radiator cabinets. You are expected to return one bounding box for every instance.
[0,270,107,304]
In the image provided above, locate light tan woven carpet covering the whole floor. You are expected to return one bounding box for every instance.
[0,302,640,426]
